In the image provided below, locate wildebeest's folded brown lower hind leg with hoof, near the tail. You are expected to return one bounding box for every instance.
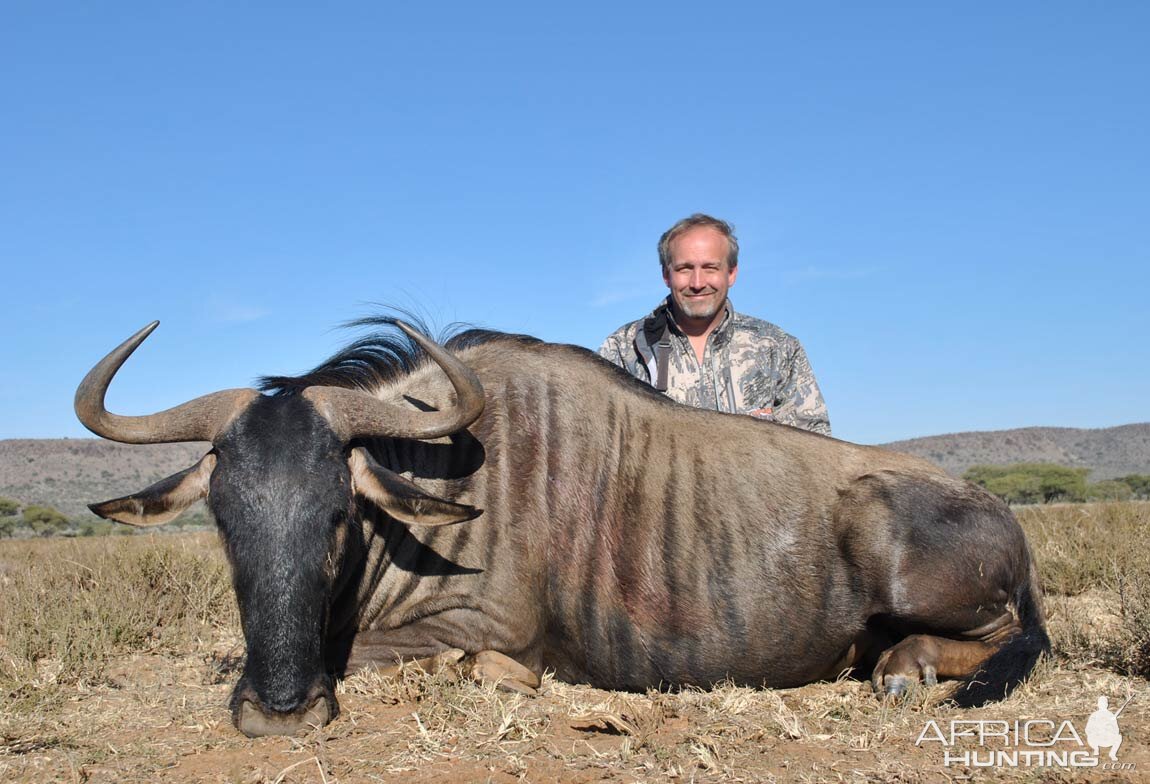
[871,613,1021,695]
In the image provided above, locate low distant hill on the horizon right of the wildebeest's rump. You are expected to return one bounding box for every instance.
[882,422,1150,482]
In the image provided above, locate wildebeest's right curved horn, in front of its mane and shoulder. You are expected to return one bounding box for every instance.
[304,320,485,441]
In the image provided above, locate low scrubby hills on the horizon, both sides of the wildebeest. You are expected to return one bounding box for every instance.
[0,423,1150,518]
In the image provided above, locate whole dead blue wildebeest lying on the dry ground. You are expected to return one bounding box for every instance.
[76,318,1049,736]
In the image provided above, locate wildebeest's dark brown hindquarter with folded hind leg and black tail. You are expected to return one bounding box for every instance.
[836,471,1050,706]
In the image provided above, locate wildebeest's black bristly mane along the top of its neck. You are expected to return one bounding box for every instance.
[256,313,542,395]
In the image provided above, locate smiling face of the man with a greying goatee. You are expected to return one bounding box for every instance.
[662,226,738,318]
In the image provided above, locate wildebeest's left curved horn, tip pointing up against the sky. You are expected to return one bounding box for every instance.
[76,321,259,444]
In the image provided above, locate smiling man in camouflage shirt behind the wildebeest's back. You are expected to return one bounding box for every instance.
[599,214,830,436]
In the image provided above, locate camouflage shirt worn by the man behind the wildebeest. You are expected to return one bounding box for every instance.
[599,298,830,436]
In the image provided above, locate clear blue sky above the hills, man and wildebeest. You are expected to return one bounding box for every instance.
[0,2,1150,443]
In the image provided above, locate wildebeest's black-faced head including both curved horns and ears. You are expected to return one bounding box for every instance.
[76,322,484,736]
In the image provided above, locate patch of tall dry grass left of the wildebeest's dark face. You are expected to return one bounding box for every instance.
[0,536,238,700]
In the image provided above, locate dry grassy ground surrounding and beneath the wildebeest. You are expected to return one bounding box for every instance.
[0,502,1150,784]
